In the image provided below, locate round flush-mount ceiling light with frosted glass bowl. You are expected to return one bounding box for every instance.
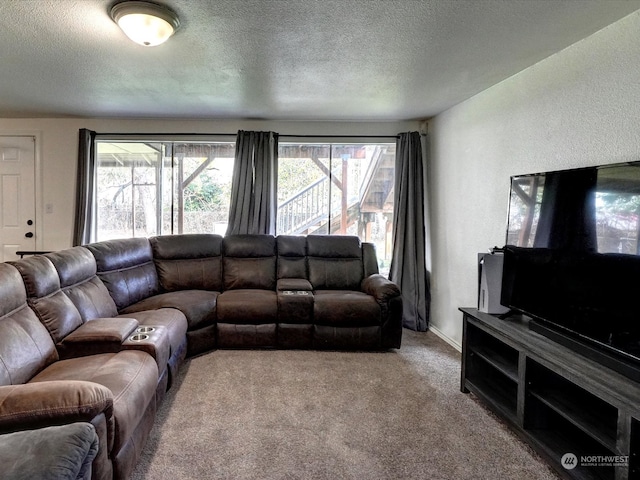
[111,2,180,47]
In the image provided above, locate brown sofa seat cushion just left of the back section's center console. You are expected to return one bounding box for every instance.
[218,289,278,325]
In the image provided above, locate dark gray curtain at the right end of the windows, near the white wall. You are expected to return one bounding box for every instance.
[389,132,431,332]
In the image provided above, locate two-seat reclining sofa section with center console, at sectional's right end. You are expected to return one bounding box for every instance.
[211,235,402,349]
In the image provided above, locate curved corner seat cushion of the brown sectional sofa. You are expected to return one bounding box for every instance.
[120,290,220,330]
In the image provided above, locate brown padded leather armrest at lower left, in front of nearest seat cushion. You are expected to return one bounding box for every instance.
[0,380,113,432]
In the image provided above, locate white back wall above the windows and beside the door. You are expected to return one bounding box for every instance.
[0,118,418,250]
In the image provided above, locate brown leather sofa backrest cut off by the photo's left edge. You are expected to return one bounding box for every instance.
[0,263,58,385]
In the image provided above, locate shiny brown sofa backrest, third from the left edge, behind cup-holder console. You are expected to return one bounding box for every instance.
[45,247,118,322]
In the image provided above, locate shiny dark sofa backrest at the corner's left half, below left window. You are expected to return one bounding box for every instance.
[86,238,160,310]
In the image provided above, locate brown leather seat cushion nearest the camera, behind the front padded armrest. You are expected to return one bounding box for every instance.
[29,350,158,452]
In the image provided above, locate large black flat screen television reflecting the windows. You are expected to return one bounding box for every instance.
[501,162,640,381]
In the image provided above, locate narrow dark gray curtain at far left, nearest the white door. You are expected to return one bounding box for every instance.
[73,128,96,246]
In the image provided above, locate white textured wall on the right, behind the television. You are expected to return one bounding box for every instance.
[429,11,640,343]
